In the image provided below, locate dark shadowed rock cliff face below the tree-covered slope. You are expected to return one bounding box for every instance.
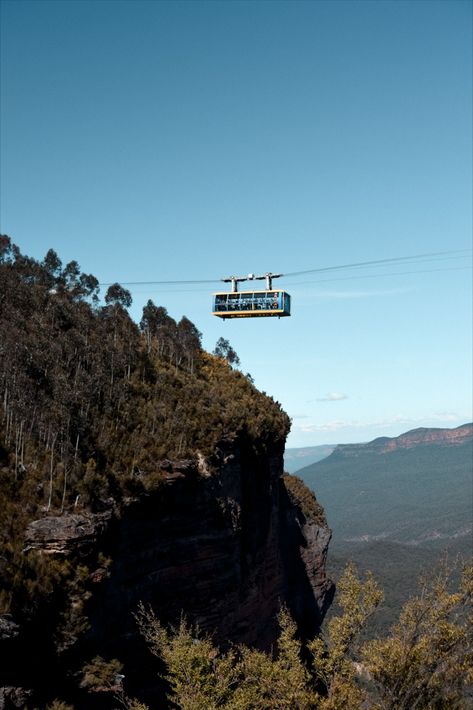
[12,438,334,700]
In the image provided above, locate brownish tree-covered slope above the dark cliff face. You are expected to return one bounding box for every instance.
[0,236,289,614]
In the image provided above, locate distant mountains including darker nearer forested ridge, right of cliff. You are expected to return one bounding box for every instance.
[296,424,473,636]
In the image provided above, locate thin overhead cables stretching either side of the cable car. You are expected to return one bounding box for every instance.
[99,249,471,286]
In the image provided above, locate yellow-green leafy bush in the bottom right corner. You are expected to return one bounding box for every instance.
[362,565,473,710]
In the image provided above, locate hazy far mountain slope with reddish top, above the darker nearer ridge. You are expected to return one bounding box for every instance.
[297,424,473,545]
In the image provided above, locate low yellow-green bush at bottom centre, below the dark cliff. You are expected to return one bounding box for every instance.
[137,606,316,710]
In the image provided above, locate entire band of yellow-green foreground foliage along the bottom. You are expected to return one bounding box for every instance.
[137,566,473,710]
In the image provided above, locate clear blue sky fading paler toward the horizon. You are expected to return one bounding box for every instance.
[0,0,472,446]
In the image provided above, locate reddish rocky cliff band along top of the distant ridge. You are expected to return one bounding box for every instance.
[334,424,473,457]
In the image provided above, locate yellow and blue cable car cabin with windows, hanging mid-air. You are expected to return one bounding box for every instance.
[213,291,291,318]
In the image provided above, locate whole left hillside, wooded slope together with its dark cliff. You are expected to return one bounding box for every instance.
[0,237,333,709]
